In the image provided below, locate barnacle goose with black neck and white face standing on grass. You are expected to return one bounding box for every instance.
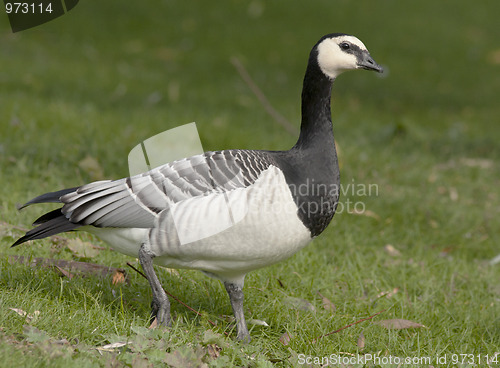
[13,33,382,341]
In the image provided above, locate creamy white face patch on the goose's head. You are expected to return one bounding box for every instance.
[318,36,366,79]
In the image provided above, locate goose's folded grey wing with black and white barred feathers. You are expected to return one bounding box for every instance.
[60,150,272,228]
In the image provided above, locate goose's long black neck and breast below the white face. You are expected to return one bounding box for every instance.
[284,49,340,236]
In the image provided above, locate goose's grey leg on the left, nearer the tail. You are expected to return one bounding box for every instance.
[139,245,171,327]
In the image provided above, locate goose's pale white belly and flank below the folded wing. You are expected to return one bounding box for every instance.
[149,166,311,277]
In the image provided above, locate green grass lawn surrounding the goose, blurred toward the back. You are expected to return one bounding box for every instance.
[0,0,500,367]
